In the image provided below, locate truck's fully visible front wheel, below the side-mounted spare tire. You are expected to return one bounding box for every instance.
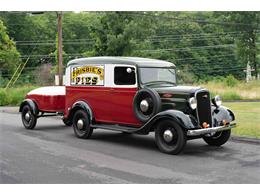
[155,120,187,154]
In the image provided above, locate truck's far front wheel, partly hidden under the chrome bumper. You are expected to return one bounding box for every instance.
[203,129,231,146]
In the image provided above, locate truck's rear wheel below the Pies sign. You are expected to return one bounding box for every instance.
[72,110,93,139]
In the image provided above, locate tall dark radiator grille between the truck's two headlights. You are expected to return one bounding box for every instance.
[195,91,212,127]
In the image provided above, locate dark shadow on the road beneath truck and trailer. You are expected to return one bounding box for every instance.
[15,124,238,157]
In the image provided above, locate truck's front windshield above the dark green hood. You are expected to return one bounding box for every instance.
[139,67,176,85]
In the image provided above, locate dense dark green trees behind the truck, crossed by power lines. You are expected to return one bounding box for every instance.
[0,12,260,83]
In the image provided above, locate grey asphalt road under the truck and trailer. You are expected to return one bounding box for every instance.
[0,113,260,183]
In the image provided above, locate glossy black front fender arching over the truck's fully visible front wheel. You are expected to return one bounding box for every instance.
[142,110,198,133]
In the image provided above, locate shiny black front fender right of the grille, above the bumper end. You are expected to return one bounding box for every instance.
[211,105,235,126]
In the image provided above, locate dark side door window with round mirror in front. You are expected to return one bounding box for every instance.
[114,66,136,85]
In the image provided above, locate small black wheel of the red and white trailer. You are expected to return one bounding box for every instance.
[21,104,37,129]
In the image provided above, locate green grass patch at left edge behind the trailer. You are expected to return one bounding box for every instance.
[0,86,37,106]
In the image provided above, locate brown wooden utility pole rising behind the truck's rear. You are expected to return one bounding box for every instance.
[57,12,63,86]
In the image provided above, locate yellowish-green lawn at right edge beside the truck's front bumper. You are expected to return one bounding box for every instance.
[224,102,260,138]
